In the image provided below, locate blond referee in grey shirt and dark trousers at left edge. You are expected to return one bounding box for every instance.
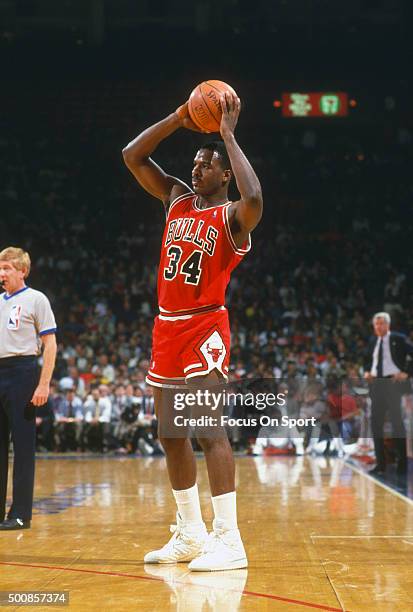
[0,247,56,531]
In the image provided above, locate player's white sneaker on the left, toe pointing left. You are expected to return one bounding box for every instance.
[143,512,208,563]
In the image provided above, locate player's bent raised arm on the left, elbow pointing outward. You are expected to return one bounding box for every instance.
[122,102,198,205]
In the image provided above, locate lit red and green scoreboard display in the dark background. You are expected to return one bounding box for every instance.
[281,92,348,117]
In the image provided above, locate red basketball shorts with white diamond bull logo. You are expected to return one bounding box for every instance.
[146,308,231,389]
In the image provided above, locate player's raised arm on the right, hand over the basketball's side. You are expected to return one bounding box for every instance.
[220,93,263,234]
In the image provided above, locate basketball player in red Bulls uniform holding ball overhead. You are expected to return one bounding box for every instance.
[123,93,263,571]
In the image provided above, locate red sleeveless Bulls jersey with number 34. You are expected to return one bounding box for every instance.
[158,193,251,316]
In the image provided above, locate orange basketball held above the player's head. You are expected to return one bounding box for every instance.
[188,80,237,133]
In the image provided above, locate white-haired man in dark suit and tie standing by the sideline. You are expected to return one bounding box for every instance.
[364,312,413,476]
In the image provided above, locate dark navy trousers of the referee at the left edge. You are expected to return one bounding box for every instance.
[0,357,39,521]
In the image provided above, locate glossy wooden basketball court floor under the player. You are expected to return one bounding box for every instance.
[0,456,413,612]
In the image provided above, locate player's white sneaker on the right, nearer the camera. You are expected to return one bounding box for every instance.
[188,519,248,572]
